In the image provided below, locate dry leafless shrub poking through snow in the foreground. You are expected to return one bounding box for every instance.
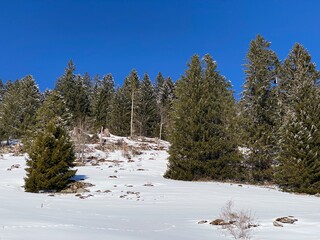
[220,201,257,240]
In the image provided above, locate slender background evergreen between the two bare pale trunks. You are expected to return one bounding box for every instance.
[136,74,159,137]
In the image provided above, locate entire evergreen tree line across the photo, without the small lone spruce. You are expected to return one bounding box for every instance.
[0,35,320,194]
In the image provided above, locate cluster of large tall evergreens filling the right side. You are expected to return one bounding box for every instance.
[165,35,320,194]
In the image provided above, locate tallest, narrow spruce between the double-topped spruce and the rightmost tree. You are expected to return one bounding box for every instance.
[241,35,279,182]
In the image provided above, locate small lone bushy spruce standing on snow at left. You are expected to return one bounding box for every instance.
[25,119,76,192]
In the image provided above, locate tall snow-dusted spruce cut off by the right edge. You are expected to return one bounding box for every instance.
[276,44,320,194]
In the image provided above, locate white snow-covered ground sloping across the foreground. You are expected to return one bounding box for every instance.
[0,137,320,240]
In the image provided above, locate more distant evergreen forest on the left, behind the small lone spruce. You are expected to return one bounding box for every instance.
[0,61,174,141]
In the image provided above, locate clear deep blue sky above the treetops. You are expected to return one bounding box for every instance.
[0,0,320,97]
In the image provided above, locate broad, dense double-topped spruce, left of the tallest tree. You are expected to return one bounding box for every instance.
[165,55,240,180]
